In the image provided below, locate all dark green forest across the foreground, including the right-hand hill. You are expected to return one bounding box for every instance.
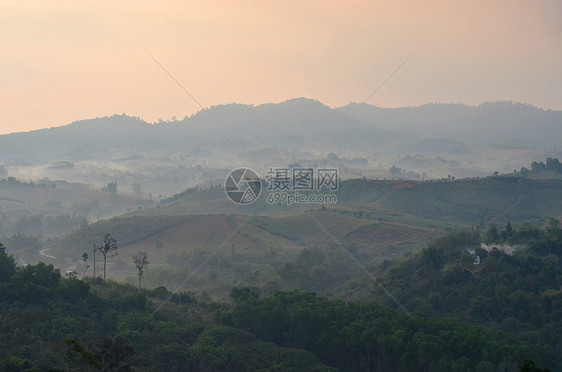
[0,218,562,371]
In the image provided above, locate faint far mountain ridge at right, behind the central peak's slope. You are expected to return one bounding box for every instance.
[338,102,562,149]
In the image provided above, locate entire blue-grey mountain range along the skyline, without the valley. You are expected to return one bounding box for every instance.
[0,98,562,176]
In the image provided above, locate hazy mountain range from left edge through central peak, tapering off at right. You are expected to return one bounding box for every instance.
[0,98,414,163]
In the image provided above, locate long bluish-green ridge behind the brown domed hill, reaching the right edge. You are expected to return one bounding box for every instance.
[153,174,562,227]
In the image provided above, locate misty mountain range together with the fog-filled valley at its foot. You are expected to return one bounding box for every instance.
[0,98,562,195]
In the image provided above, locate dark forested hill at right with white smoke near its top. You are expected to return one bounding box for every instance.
[348,218,562,370]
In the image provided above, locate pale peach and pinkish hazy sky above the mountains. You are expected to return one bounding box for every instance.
[0,0,562,133]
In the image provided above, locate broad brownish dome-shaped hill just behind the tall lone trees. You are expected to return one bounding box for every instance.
[49,212,443,298]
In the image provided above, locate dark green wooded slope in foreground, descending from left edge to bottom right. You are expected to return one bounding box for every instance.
[0,247,560,372]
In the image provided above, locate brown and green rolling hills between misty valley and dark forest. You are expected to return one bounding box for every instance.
[44,176,562,297]
